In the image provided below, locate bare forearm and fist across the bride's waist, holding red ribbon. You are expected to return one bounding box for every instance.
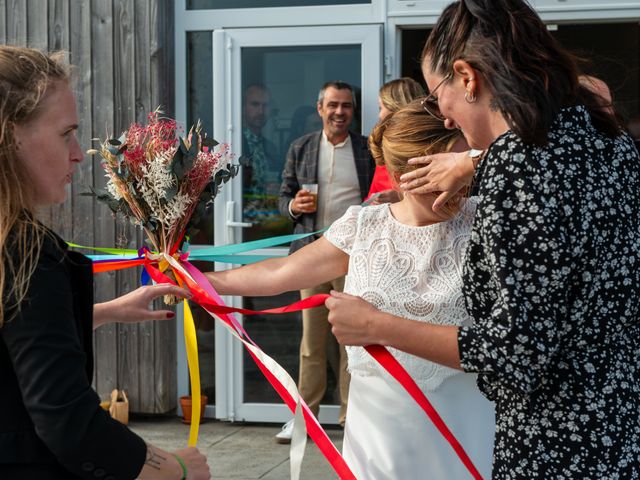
[325,292,462,370]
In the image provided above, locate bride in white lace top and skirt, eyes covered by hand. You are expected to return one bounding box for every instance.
[207,101,494,480]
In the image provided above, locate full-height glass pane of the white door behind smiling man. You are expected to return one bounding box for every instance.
[241,45,362,404]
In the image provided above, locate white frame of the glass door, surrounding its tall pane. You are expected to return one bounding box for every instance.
[177,24,382,423]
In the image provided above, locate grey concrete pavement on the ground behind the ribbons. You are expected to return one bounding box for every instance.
[129,416,342,480]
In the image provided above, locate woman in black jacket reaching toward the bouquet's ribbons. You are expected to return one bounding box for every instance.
[0,46,210,480]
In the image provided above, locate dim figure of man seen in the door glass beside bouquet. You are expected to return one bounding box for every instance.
[240,83,282,240]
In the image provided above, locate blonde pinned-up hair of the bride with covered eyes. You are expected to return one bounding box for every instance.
[369,100,463,216]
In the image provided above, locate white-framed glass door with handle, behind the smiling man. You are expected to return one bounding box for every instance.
[213,25,382,423]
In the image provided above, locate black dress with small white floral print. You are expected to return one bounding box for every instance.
[458,107,640,480]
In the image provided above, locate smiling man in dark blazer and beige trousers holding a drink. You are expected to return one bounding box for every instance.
[276,81,375,443]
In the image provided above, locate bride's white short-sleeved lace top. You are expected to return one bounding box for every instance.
[324,197,477,390]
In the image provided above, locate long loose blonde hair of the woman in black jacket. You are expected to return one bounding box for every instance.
[0,45,70,327]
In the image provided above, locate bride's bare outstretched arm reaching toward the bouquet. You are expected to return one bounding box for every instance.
[206,237,349,296]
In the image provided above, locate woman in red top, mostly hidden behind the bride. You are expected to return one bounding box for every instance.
[365,77,425,205]
